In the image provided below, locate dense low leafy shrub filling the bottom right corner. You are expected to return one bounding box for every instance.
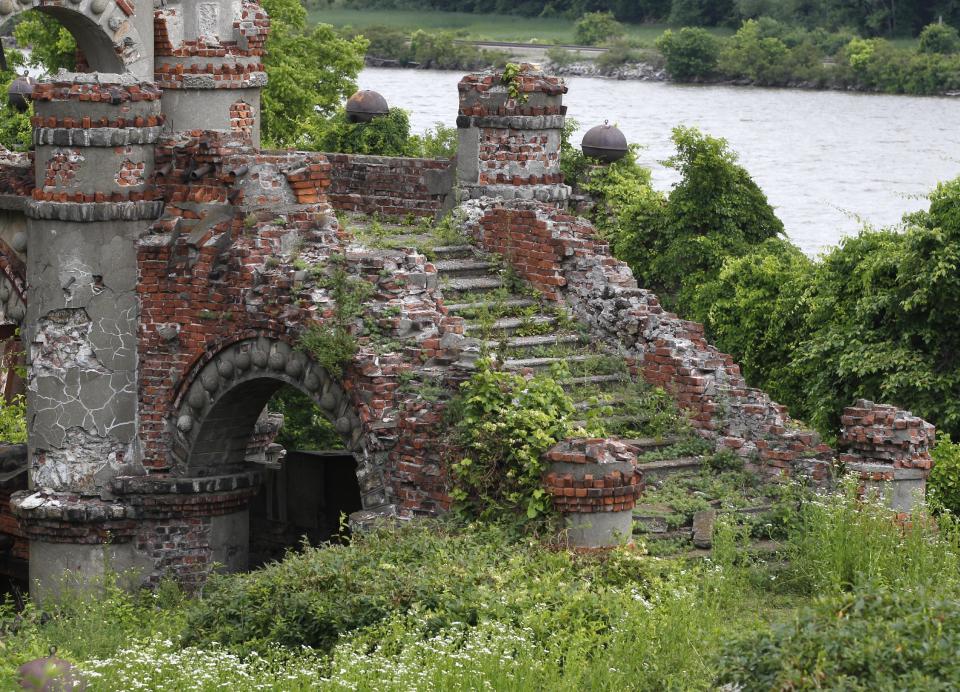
[717,585,960,692]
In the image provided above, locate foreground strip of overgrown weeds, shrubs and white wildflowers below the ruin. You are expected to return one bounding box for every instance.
[9,492,960,690]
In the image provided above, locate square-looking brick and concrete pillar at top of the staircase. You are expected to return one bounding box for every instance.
[457,63,570,204]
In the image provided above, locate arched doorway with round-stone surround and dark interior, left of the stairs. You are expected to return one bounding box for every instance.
[172,337,379,568]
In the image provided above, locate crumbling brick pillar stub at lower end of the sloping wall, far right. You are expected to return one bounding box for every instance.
[840,399,936,511]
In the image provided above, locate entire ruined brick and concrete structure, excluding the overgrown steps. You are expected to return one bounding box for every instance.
[0,0,932,596]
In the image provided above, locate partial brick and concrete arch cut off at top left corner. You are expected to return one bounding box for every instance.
[0,0,153,78]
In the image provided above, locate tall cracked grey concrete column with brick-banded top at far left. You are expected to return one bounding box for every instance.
[18,72,163,596]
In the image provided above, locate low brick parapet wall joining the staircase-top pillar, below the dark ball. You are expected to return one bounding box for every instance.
[325,154,454,217]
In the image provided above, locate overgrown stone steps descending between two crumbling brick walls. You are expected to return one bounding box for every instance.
[341,216,772,556]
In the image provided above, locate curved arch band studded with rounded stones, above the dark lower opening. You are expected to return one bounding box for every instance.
[169,336,371,502]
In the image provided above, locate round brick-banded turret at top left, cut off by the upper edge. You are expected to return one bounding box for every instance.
[155,0,270,147]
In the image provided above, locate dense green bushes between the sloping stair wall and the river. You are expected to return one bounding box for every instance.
[580,123,960,437]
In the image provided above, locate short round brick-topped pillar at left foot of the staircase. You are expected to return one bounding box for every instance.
[544,438,643,548]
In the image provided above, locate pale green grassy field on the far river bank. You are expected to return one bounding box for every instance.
[310,9,732,45]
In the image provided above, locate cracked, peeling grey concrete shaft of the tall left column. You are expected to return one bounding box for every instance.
[24,220,142,495]
